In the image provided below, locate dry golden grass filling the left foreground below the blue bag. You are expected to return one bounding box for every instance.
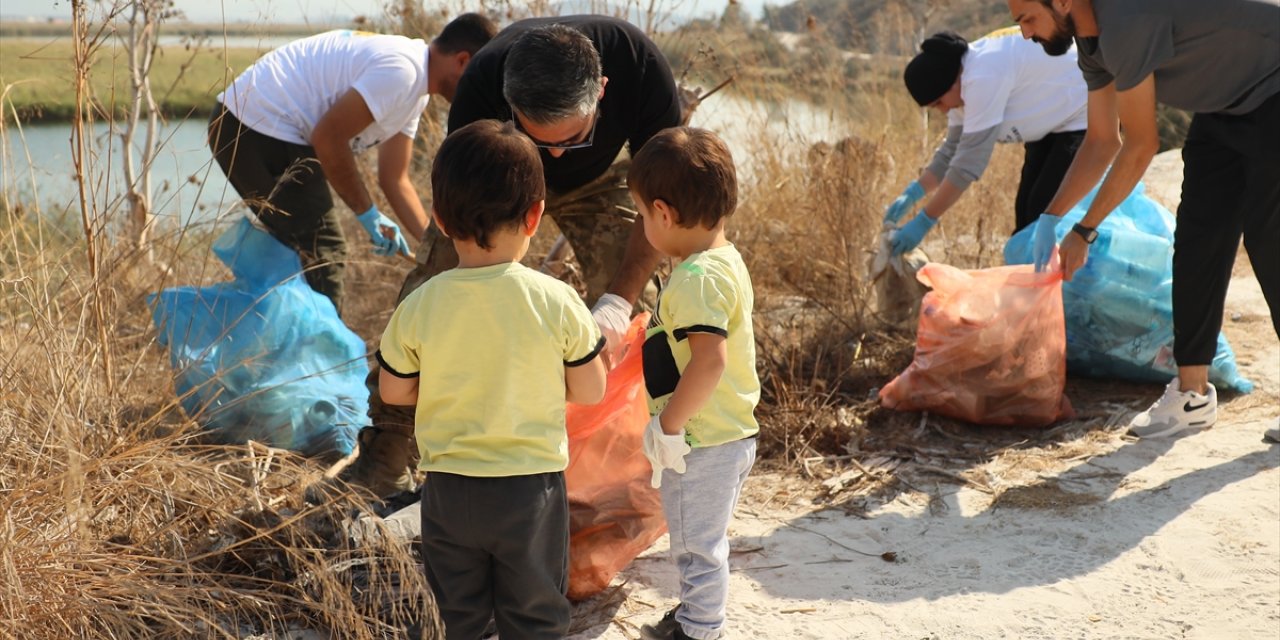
[0,218,445,637]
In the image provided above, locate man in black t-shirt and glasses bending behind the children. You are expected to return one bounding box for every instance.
[343,15,681,495]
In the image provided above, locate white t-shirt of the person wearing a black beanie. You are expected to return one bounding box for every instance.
[947,27,1088,143]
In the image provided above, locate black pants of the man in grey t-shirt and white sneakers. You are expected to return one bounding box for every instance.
[1174,93,1280,366]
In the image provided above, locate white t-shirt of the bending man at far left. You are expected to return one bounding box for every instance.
[218,29,428,154]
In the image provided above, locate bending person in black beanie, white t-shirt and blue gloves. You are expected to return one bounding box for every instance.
[884,28,1088,253]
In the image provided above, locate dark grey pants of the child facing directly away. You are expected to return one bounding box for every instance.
[422,472,571,640]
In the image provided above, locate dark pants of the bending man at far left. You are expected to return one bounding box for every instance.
[209,104,347,314]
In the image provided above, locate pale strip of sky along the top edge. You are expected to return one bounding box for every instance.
[0,0,787,23]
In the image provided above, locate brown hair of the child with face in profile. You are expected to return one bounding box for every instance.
[627,127,737,229]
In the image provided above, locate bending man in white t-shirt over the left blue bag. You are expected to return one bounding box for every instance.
[209,13,497,312]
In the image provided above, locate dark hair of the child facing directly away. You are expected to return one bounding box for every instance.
[431,120,547,248]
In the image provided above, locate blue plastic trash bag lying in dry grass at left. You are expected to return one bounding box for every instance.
[148,219,369,456]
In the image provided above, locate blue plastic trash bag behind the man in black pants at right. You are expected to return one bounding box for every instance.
[1005,183,1253,393]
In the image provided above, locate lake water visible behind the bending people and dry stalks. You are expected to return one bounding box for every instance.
[0,93,849,227]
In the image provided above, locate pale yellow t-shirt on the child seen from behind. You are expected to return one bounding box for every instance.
[378,262,604,477]
